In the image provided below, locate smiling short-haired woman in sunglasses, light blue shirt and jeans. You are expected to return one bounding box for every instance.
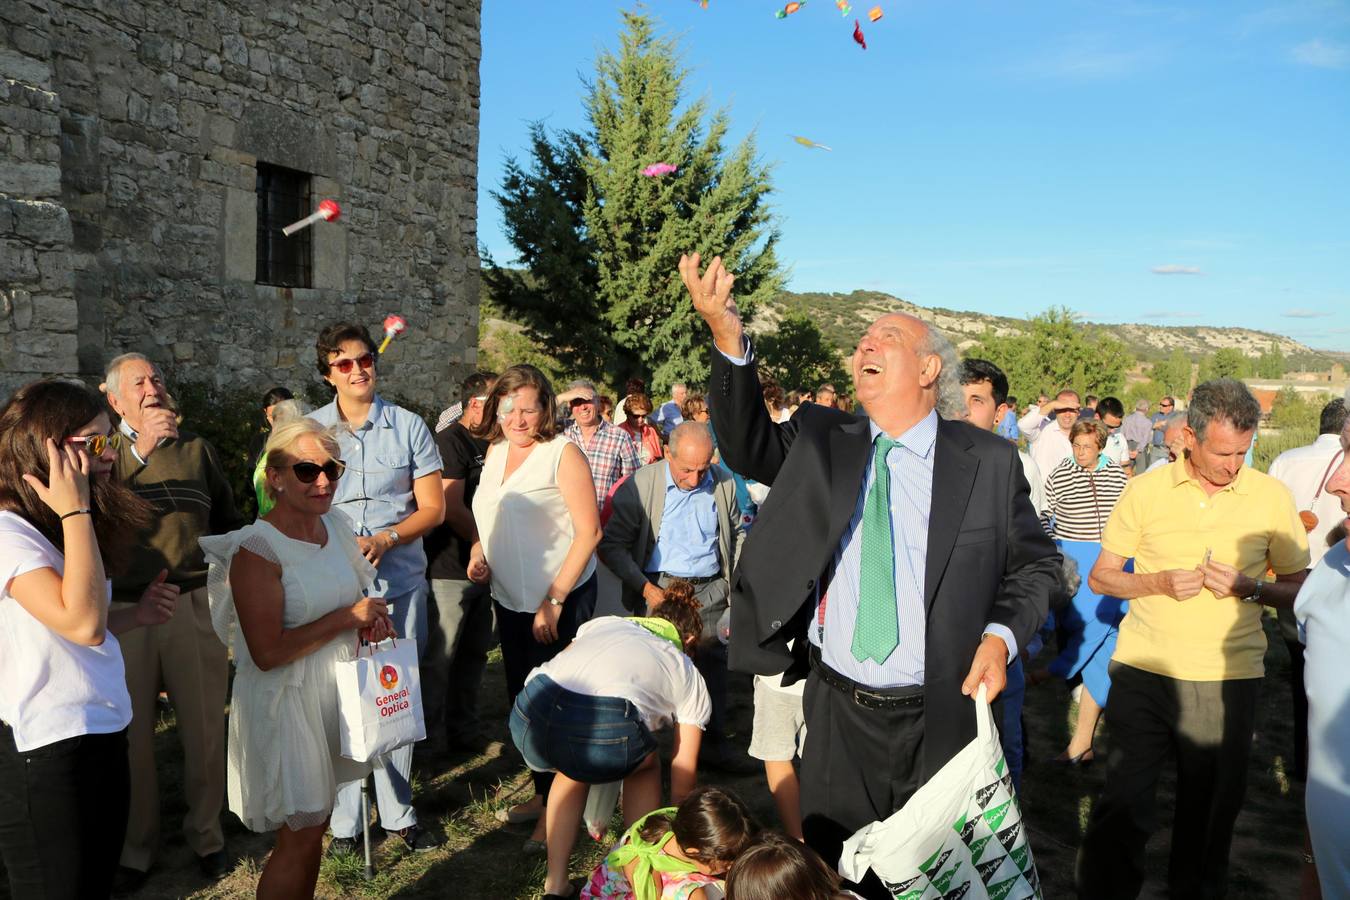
[309,322,446,854]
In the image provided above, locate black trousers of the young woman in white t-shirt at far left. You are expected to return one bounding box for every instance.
[0,725,131,900]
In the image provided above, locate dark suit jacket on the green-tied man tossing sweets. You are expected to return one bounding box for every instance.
[707,347,1060,779]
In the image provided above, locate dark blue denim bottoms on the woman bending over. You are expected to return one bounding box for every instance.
[510,675,656,784]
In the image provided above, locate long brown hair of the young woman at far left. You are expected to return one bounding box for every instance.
[0,378,154,575]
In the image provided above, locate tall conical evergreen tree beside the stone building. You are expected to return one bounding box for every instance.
[483,12,782,394]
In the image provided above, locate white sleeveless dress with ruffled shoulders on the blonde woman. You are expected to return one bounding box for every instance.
[200,513,375,831]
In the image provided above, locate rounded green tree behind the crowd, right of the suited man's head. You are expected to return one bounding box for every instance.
[967,306,1134,398]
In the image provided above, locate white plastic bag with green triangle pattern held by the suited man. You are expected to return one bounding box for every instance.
[840,684,1041,900]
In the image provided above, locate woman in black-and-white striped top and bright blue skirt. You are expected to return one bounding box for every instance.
[1031,418,1129,765]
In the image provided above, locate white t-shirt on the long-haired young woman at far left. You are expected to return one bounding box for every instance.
[0,510,131,753]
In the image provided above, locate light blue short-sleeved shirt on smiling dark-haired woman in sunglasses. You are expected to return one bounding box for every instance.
[309,394,440,596]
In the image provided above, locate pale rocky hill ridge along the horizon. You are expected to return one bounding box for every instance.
[751,290,1350,371]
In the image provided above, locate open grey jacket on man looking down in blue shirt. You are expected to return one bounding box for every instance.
[598,460,745,611]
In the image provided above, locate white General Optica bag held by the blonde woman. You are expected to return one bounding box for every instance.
[333,641,427,762]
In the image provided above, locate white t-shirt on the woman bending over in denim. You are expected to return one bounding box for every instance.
[525,615,713,731]
